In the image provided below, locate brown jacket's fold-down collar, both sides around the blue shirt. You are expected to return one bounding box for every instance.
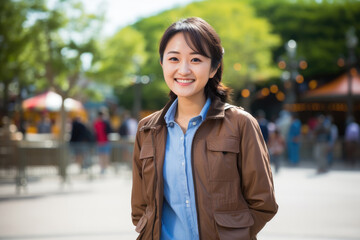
[140,97,227,131]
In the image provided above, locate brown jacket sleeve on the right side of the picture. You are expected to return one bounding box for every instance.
[239,113,278,239]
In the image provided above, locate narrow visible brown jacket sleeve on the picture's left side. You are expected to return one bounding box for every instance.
[131,124,146,226]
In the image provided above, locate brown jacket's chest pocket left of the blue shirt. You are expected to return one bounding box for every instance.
[139,144,155,199]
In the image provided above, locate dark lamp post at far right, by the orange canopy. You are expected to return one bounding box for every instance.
[346,27,358,119]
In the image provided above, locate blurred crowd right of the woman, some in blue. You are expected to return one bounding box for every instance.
[256,110,360,173]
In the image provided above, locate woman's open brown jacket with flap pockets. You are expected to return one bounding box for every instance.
[131,96,278,240]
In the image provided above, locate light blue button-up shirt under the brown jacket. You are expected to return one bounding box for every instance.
[160,98,211,240]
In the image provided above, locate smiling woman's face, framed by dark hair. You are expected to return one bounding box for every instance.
[161,32,217,101]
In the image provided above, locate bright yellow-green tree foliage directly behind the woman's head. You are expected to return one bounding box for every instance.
[102,0,280,109]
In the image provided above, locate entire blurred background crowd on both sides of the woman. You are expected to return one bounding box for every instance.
[0,109,360,173]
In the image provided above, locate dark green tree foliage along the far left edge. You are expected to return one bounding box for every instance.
[0,0,36,116]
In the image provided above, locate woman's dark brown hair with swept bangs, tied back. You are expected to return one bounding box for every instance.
[159,17,230,102]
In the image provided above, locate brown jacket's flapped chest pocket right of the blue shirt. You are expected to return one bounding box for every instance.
[206,138,240,181]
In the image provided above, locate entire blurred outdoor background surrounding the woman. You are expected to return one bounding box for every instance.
[0,0,360,240]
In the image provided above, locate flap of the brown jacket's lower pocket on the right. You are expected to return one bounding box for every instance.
[214,210,254,228]
